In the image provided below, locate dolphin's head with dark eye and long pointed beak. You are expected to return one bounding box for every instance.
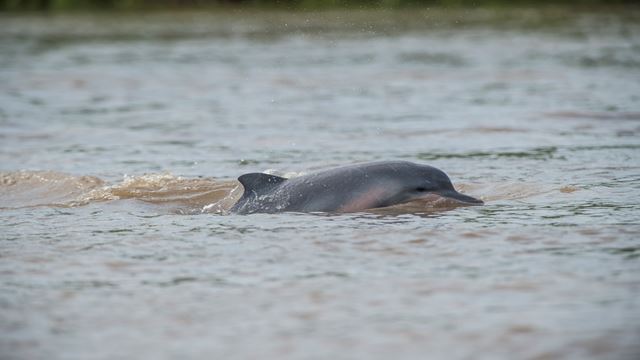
[372,162,483,205]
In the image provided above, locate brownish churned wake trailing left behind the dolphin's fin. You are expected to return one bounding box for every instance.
[0,171,239,213]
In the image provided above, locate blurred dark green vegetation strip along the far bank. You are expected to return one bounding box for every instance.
[0,0,639,11]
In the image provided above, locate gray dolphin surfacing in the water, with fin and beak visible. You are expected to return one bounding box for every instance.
[230,161,483,214]
